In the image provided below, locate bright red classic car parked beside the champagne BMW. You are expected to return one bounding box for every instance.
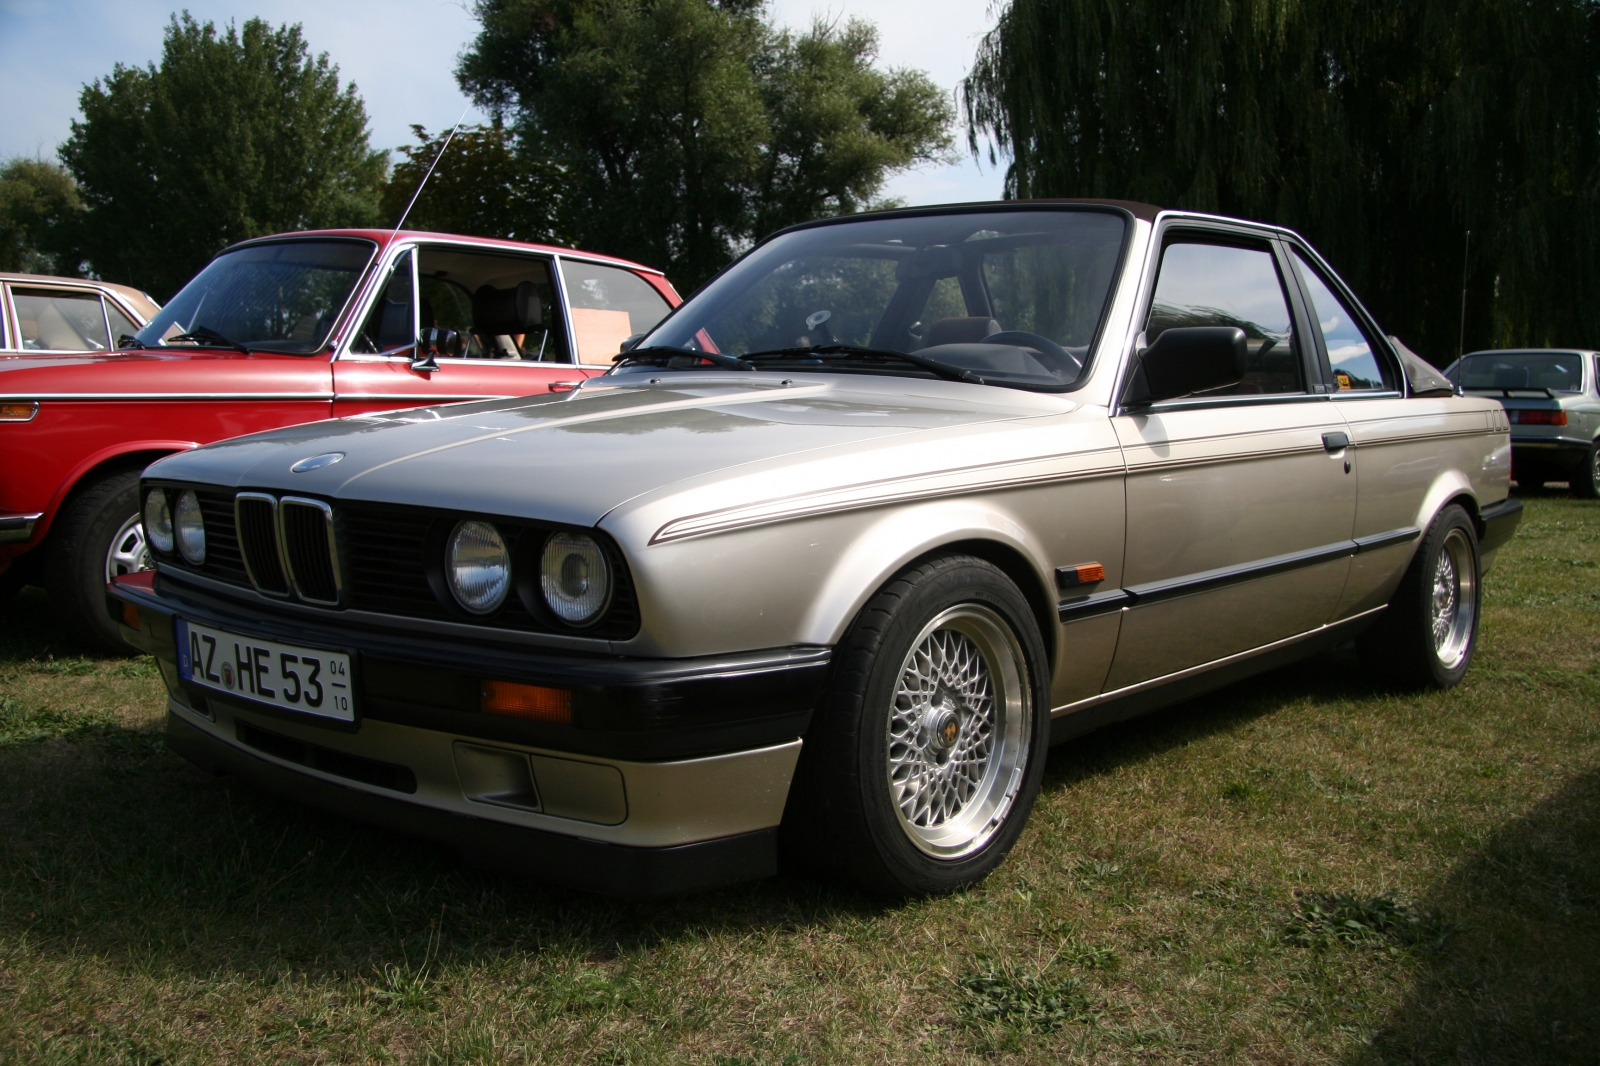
[0,230,678,650]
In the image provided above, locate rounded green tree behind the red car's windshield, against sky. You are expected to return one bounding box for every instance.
[59,11,386,298]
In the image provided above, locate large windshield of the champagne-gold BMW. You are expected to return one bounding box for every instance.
[613,210,1126,391]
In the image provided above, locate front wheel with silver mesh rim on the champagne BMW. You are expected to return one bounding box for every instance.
[779,555,1050,900]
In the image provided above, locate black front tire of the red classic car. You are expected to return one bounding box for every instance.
[45,471,144,655]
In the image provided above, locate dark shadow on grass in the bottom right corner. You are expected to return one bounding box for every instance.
[1347,770,1600,1066]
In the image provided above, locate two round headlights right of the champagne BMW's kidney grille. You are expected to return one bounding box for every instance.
[445,520,611,626]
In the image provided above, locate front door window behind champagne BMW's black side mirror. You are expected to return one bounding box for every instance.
[1144,240,1306,395]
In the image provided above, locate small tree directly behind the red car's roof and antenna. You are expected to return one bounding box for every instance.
[381,123,565,243]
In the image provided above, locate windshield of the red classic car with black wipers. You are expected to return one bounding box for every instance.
[136,240,376,354]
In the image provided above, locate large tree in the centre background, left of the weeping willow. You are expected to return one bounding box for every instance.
[458,0,954,288]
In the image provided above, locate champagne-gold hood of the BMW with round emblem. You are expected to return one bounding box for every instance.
[149,371,1075,525]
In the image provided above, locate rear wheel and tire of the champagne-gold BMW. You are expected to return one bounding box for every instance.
[1358,504,1483,690]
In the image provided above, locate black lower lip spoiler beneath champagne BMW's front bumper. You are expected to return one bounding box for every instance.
[166,712,778,900]
